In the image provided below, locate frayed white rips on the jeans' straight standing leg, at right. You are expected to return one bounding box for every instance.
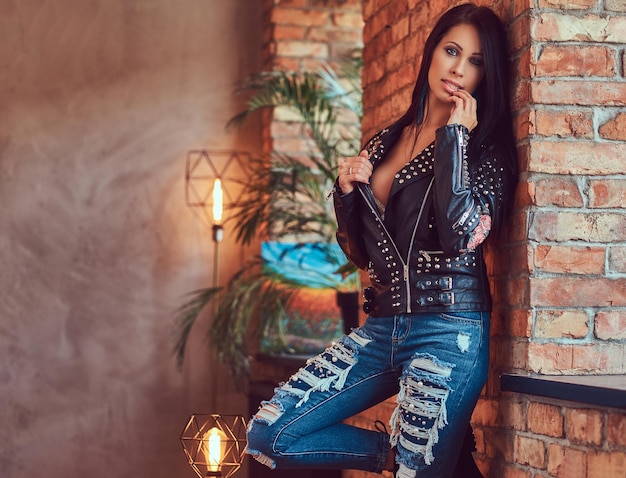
[390,353,454,478]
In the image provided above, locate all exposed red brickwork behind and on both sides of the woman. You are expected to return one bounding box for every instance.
[265,0,626,478]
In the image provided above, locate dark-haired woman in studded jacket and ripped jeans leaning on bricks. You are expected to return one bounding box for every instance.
[248,4,516,478]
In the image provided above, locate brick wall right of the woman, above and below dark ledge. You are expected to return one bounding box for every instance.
[474,0,626,478]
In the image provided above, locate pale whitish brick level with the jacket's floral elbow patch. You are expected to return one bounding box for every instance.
[529,211,626,243]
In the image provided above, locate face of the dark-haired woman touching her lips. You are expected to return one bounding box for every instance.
[428,24,484,103]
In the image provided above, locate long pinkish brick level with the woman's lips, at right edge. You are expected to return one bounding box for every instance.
[530,80,626,106]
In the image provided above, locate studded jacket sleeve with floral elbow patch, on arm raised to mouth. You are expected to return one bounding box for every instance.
[434,124,506,254]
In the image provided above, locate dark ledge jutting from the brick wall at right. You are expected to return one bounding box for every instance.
[500,373,626,409]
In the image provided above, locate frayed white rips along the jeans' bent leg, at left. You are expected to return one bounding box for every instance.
[246,329,371,468]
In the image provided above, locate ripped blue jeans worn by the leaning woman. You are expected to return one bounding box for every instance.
[247,311,490,478]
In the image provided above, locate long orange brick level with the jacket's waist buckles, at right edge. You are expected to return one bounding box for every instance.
[530,277,626,307]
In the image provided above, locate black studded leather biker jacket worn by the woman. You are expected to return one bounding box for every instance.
[334,124,506,317]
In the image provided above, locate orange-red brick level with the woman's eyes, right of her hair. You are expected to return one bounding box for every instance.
[535,45,616,77]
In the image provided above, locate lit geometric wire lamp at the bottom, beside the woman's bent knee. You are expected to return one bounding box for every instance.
[180,413,246,478]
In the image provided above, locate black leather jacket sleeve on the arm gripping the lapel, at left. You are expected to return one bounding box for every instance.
[333,184,369,269]
